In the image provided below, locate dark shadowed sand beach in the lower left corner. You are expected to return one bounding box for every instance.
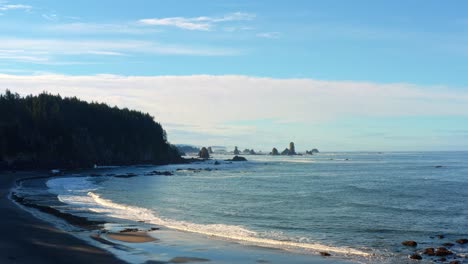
[0,172,125,264]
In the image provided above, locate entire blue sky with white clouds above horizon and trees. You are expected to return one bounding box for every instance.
[0,0,468,151]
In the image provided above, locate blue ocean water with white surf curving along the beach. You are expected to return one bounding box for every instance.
[16,152,468,263]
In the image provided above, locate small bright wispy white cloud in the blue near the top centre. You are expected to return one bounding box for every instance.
[139,12,255,31]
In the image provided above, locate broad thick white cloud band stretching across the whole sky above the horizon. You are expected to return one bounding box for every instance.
[0,74,468,127]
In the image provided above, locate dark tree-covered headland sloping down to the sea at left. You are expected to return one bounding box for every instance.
[0,90,183,168]
